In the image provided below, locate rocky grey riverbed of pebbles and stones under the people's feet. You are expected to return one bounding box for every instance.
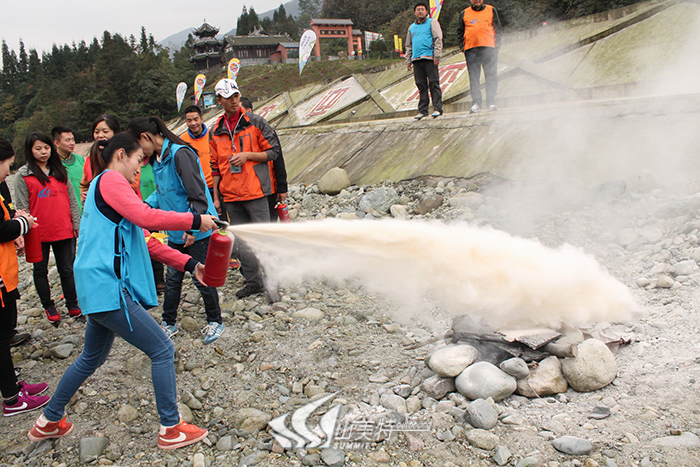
[0,173,700,467]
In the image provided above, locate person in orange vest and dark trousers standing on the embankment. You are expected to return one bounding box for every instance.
[457,0,501,113]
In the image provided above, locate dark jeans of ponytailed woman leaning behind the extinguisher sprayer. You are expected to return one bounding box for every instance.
[163,237,223,326]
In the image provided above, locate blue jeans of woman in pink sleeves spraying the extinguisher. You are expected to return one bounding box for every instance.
[44,291,180,426]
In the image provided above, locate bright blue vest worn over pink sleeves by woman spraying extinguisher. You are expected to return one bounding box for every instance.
[73,172,158,325]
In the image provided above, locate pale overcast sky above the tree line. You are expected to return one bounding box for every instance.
[0,0,286,56]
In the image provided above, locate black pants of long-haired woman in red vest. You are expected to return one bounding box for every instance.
[34,238,78,309]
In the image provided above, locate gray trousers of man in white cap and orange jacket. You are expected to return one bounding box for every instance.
[224,197,270,287]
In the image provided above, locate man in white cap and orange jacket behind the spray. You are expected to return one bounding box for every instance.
[209,79,281,298]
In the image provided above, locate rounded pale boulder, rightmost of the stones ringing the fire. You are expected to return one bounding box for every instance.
[561,339,617,392]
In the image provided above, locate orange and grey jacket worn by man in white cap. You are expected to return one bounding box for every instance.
[209,108,280,203]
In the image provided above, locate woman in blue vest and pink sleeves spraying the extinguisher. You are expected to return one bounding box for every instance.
[29,134,215,449]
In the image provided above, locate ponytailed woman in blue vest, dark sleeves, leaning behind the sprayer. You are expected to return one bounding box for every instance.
[124,117,224,344]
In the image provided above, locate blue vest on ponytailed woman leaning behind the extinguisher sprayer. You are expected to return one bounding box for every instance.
[149,138,218,245]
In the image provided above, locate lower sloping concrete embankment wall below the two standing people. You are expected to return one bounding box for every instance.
[279,94,700,190]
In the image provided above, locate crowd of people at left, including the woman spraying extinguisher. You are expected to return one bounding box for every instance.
[0,79,287,449]
